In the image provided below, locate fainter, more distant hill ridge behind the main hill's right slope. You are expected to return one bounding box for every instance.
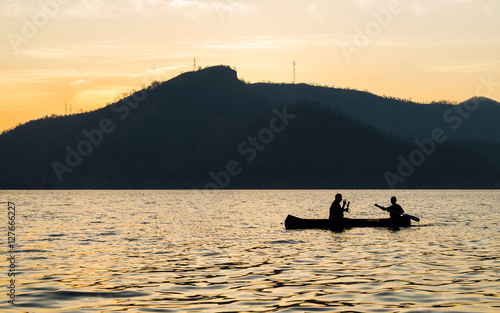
[251,83,500,142]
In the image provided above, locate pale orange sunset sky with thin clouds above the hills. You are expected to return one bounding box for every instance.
[0,0,500,131]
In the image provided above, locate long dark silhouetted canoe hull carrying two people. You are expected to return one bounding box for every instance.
[285,215,411,229]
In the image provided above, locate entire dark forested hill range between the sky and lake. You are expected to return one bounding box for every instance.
[0,66,500,188]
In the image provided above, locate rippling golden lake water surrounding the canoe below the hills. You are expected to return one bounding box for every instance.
[0,190,500,313]
